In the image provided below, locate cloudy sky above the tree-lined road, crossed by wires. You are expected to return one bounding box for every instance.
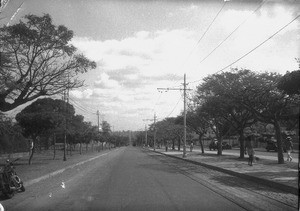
[0,0,300,130]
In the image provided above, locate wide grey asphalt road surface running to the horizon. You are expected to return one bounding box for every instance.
[1,147,296,210]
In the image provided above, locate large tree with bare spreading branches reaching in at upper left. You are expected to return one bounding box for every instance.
[0,14,96,111]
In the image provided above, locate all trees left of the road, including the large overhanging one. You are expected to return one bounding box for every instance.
[0,14,128,163]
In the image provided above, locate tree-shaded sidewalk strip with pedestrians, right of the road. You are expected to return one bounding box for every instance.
[151,149,299,195]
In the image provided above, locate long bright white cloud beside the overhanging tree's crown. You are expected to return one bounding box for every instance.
[72,29,196,75]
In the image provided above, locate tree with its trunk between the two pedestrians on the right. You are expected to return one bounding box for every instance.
[239,72,300,164]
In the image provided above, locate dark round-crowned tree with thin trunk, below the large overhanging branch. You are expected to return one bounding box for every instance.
[16,98,75,164]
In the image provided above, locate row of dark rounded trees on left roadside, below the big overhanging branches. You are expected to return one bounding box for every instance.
[16,98,125,164]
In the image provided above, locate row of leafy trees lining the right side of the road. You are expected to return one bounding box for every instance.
[138,65,300,164]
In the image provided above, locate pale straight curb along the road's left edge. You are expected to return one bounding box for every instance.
[24,149,112,187]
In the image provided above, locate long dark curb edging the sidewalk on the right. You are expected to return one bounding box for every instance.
[150,150,299,195]
